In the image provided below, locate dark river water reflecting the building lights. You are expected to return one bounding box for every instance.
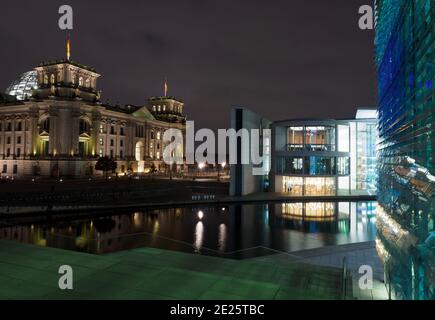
[0,202,376,258]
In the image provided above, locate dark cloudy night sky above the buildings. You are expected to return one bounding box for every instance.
[0,0,377,129]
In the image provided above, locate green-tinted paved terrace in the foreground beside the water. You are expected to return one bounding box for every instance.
[0,240,348,300]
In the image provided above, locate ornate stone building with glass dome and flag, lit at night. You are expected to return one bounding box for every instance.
[0,44,185,178]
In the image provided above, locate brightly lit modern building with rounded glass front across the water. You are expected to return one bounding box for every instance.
[270,109,377,196]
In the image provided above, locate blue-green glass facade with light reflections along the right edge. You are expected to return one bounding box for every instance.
[375,0,435,299]
